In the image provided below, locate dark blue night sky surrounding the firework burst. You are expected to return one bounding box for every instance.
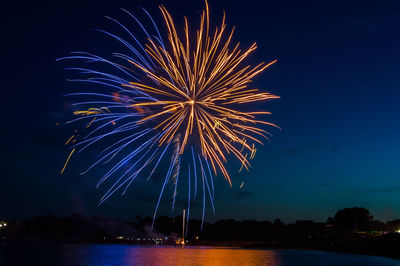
[0,0,400,222]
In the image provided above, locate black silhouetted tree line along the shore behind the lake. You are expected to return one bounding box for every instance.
[0,207,400,257]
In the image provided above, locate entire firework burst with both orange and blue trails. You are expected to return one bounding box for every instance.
[59,2,279,230]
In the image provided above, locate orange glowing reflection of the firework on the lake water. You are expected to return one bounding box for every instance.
[124,247,281,266]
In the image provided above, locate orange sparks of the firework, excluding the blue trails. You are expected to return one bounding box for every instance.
[123,2,279,184]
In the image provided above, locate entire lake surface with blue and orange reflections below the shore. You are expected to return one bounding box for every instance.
[0,243,400,266]
